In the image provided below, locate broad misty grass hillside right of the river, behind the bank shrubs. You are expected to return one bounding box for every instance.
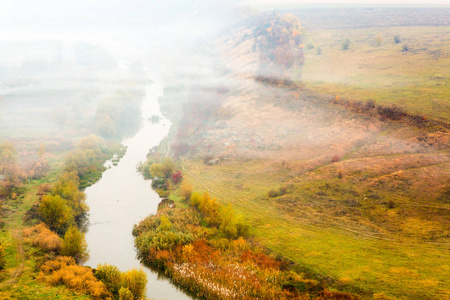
[164,8,450,299]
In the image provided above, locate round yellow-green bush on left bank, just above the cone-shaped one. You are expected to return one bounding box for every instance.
[38,195,74,233]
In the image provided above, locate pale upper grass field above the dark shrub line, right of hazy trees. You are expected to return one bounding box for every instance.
[303,27,450,122]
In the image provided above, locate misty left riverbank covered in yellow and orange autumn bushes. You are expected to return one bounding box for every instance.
[0,78,151,299]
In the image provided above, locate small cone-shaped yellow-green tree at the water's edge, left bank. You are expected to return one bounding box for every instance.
[61,226,89,263]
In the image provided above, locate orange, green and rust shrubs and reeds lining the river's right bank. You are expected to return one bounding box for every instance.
[133,158,359,299]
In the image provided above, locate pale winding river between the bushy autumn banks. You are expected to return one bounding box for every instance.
[85,83,192,300]
